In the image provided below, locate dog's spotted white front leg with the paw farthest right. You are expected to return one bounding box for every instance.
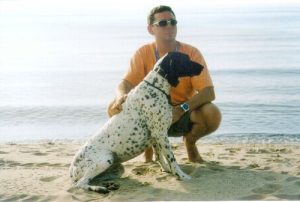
[156,133,191,180]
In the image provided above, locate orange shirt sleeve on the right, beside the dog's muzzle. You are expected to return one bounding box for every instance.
[191,48,213,90]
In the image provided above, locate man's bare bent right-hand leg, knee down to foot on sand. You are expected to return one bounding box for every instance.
[183,103,222,163]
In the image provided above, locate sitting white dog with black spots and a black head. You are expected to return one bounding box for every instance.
[70,52,203,193]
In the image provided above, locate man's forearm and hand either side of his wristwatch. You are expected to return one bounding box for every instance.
[172,86,215,123]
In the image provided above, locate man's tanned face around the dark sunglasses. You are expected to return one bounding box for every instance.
[150,11,177,41]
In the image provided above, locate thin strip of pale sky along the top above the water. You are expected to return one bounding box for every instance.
[0,0,299,16]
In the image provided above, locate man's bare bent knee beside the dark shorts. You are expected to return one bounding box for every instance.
[191,103,222,135]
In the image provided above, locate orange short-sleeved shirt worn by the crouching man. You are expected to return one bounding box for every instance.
[123,42,213,104]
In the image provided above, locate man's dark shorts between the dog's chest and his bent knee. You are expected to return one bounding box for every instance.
[168,111,193,137]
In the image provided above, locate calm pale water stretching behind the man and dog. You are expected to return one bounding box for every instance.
[0,2,300,143]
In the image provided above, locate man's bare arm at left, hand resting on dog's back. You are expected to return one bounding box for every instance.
[107,80,134,117]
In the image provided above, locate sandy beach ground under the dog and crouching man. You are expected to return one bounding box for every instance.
[0,142,300,201]
